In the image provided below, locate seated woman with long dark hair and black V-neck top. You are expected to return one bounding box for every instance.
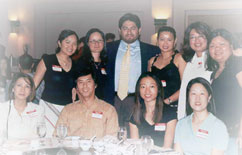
[129,72,177,148]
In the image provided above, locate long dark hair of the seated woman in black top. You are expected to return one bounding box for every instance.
[133,72,164,124]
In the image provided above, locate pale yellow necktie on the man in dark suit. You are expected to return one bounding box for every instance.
[118,45,130,100]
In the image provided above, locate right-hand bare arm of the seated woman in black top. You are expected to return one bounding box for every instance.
[163,119,177,148]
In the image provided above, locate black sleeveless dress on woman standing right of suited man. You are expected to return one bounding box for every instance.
[151,54,181,115]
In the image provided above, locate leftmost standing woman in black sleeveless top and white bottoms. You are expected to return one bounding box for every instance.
[34,30,78,136]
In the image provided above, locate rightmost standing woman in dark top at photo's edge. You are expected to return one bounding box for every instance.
[207,29,242,154]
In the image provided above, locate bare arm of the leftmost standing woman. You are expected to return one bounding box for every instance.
[33,59,46,88]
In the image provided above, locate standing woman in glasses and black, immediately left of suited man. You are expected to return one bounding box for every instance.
[77,28,107,99]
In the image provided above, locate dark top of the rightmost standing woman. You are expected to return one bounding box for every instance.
[211,56,242,135]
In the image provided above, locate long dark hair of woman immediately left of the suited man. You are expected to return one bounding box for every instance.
[80,28,107,65]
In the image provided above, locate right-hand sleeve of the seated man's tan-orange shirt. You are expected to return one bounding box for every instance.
[106,107,119,136]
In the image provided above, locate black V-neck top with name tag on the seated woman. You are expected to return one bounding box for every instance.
[130,108,176,146]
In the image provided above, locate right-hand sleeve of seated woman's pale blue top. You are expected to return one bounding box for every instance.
[212,120,229,150]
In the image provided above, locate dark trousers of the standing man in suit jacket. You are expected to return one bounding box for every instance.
[114,95,134,126]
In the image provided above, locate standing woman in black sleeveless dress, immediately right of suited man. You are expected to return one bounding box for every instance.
[148,26,186,117]
